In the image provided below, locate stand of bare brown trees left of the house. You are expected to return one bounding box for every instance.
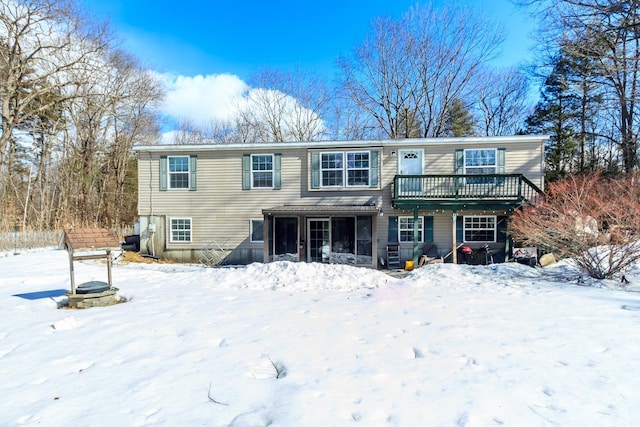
[0,0,163,230]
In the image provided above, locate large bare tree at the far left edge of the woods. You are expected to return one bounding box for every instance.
[0,0,109,227]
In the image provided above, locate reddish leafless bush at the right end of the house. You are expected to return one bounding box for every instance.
[511,174,640,279]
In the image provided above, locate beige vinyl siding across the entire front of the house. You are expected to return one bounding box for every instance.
[138,137,546,256]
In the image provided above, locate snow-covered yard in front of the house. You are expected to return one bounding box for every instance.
[0,249,640,427]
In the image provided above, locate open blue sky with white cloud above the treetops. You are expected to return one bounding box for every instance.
[79,0,534,133]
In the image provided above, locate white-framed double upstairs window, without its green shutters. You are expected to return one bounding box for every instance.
[320,151,371,187]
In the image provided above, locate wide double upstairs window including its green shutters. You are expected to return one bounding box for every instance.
[311,151,378,188]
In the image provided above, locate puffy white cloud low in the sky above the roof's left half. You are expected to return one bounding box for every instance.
[163,74,249,125]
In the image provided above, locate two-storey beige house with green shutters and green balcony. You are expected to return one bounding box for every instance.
[135,136,547,268]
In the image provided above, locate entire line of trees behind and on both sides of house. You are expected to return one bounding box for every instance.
[0,0,640,234]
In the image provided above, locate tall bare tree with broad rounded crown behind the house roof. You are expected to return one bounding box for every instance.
[339,6,502,138]
